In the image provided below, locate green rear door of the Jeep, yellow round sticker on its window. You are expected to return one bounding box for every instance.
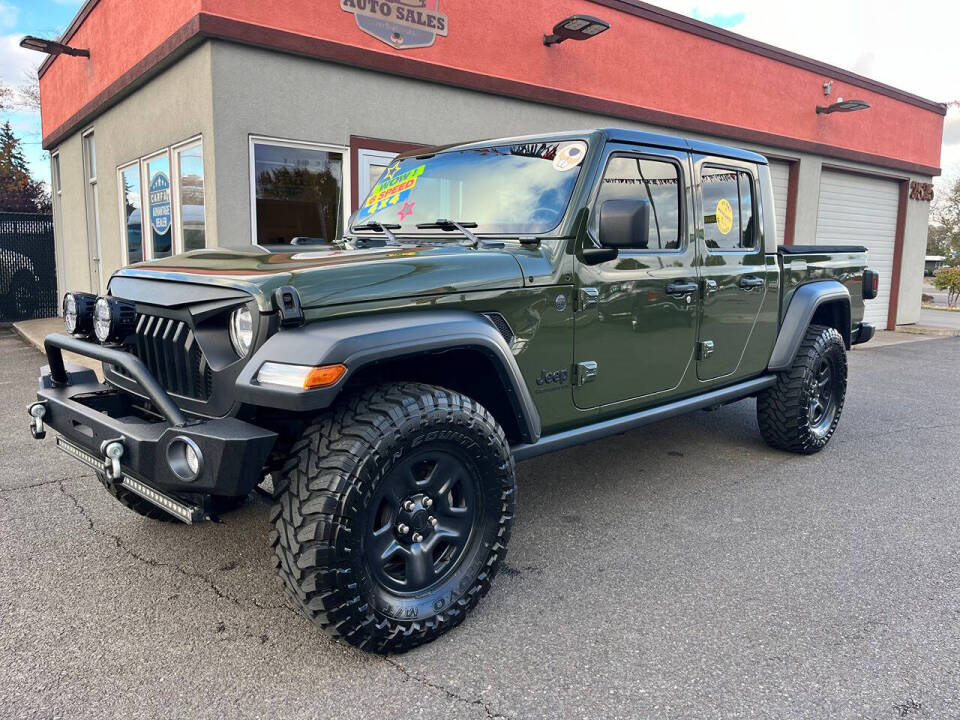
[694,156,767,380]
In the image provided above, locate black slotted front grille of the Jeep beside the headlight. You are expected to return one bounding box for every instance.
[121,315,213,400]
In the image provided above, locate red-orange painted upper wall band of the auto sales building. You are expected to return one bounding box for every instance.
[41,0,943,167]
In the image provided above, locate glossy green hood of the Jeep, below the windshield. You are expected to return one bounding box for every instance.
[114,242,523,310]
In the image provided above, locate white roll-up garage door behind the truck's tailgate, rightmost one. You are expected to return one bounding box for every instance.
[817,170,900,330]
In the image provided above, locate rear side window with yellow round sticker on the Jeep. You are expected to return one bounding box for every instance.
[700,167,757,250]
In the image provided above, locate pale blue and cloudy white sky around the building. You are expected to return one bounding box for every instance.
[0,0,960,193]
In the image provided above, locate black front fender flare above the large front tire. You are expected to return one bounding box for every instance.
[236,310,541,443]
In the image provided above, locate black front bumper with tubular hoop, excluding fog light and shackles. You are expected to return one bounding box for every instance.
[31,335,277,496]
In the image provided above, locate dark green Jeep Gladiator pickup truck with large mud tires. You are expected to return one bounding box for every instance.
[29,129,878,652]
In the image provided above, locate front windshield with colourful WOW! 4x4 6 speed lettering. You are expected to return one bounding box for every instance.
[353,140,587,234]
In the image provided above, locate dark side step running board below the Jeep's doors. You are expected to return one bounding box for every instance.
[511,375,777,461]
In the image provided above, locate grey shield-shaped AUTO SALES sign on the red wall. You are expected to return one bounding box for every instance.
[340,0,450,50]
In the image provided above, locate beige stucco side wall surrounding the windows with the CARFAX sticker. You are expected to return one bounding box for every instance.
[53,45,217,292]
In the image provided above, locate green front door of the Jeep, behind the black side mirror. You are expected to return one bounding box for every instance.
[573,146,699,408]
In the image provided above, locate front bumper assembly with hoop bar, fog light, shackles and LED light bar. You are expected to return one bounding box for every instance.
[28,334,277,523]
